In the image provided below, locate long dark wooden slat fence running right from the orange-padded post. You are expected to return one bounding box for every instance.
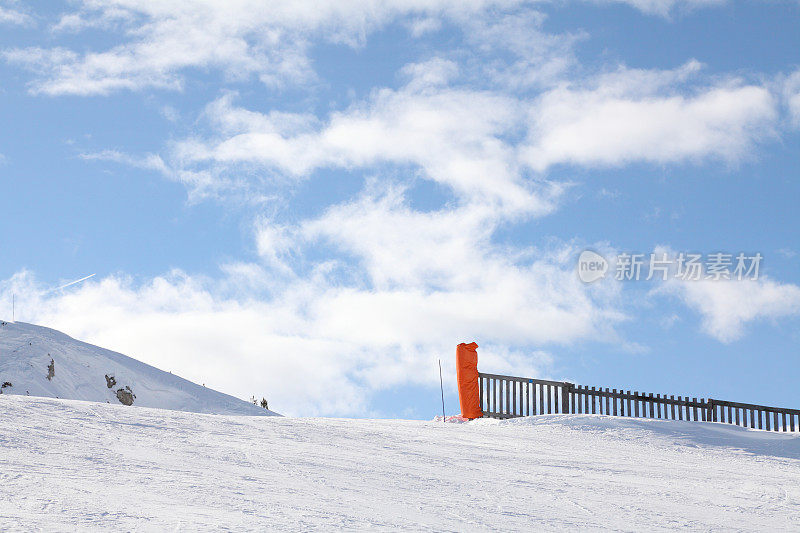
[478,372,800,431]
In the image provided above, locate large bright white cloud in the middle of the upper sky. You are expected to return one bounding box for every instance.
[171,72,560,215]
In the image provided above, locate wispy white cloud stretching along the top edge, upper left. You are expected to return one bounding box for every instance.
[6,0,528,95]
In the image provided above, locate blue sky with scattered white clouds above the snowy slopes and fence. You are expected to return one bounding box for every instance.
[0,0,800,419]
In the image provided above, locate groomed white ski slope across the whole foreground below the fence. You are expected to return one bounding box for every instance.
[0,395,800,531]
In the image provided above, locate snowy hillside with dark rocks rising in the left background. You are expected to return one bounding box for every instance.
[0,322,275,415]
